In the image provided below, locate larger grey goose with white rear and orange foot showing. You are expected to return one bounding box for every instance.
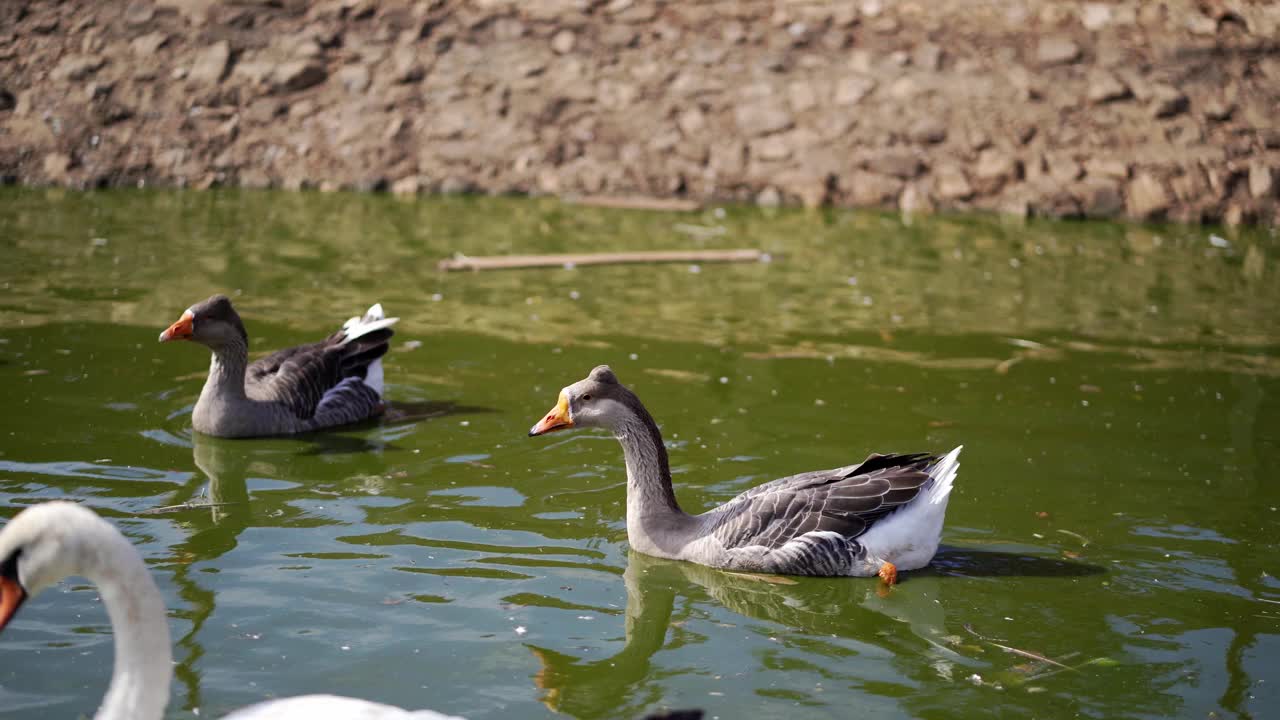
[529,365,960,584]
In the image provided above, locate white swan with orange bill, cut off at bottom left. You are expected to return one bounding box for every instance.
[0,501,461,720]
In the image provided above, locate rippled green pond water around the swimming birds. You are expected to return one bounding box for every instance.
[0,188,1280,720]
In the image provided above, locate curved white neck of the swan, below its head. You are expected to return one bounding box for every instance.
[86,532,173,720]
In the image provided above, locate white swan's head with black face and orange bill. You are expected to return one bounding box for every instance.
[0,502,105,630]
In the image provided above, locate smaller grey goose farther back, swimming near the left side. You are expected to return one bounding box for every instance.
[160,295,399,437]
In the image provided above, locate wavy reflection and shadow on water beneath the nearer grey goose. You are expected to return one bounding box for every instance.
[526,546,1105,717]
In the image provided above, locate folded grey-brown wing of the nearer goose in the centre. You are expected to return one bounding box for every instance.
[712,454,937,550]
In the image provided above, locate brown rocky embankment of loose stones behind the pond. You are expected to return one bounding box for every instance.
[0,0,1280,224]
